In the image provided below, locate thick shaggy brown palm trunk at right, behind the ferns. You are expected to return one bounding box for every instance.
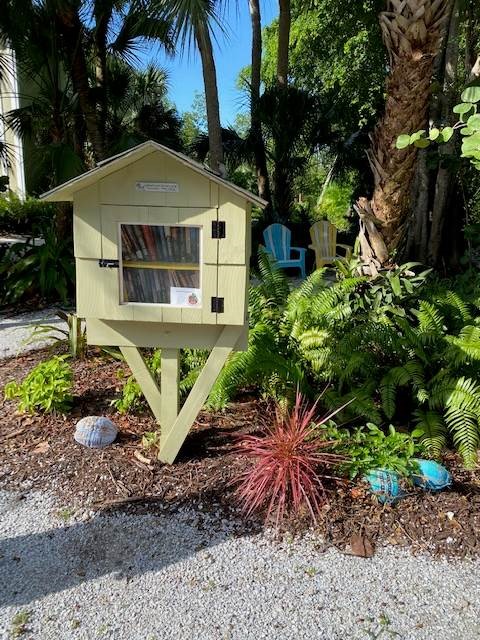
[356,0,452,271]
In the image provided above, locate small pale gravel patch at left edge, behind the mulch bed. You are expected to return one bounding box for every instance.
[0,309,66,358]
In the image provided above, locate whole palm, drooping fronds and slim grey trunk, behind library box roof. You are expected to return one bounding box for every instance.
[153,0,225,176]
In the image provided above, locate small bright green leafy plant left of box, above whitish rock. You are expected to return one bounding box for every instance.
[4,355,73,413]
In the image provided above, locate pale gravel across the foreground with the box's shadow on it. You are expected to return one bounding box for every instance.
[0,492,480,640]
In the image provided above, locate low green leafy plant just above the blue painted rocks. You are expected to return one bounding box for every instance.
[326,423,423,479]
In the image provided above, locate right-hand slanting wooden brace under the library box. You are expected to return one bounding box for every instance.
[158,326,244,464]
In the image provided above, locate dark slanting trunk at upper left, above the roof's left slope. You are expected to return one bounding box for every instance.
[57,5,105,161]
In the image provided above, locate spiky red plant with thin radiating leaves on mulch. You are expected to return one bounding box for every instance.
[236,393,340,526]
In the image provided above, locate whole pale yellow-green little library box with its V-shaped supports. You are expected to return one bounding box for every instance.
[42,141,266,463]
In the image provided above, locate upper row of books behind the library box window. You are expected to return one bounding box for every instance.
[121,224,200,264]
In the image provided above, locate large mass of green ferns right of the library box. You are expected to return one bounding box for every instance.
[214,254,480,467]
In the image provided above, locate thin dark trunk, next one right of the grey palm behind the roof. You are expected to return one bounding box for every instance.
[248,0,271,212]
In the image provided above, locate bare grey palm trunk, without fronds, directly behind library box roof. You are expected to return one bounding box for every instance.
[195,25,226,177]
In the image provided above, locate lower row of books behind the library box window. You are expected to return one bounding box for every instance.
[123,267,200,304]
